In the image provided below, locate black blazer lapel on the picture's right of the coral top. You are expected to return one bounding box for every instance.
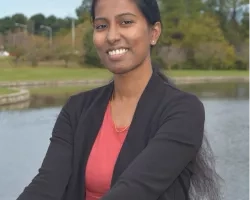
[111,73,168,186]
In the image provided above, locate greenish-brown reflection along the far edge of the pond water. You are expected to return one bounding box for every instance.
[0,82,250,110]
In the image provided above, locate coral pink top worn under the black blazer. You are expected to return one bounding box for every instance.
[85,103,127,200]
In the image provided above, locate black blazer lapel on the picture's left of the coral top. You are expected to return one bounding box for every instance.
[71,82,114,199]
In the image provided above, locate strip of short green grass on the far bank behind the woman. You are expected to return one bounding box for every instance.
[0,66,250,81]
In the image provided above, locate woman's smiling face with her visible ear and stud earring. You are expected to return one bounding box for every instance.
[93,0,160,74]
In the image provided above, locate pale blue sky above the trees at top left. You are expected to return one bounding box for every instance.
[0,0,82,18]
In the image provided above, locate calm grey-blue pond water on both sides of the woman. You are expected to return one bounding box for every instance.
[0,83,250,200]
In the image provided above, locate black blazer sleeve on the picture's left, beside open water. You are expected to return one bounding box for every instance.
[17,97,73,200]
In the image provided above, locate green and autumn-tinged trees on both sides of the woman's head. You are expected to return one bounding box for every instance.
[0,0,250,70]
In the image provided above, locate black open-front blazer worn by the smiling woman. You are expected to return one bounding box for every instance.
[17,72,205,200]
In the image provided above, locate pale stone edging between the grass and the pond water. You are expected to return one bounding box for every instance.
[0,76,250,106]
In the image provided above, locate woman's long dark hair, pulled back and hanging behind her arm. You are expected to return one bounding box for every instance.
[91,0,222,200]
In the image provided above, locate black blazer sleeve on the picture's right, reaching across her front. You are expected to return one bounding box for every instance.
[101,94,205,200]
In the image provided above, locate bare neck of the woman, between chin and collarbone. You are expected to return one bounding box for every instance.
[113,62,153,101]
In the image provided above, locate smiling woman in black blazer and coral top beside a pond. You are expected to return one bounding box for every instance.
[18,0,219,200]
